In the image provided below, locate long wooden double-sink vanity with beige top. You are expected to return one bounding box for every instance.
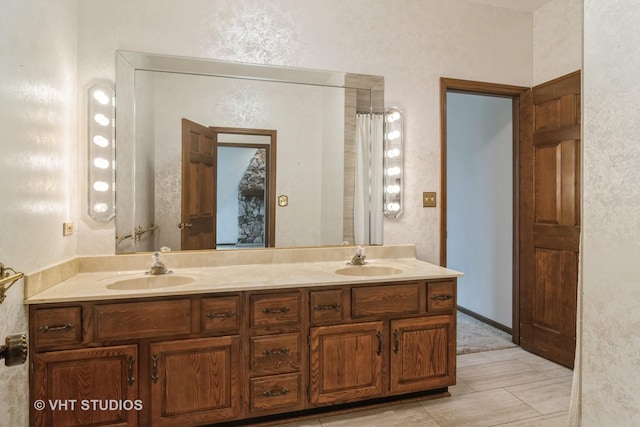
[26,247,460,426]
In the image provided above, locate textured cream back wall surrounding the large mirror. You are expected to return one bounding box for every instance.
[78,0,533,262]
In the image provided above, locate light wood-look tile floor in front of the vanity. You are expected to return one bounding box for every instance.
[281,347,573,427]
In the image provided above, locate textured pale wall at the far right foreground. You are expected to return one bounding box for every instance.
[582,0,640,427]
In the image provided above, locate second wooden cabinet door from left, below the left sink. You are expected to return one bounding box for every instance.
[149,335,241,426]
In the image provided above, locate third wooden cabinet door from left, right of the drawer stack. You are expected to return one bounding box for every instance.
[309,322,384,405]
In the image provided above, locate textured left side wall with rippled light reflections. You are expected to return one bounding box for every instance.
[0,0,77,426]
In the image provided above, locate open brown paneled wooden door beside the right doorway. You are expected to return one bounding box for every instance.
[519,72,580,367]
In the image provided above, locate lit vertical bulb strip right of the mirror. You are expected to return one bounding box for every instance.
[384,107,404,218]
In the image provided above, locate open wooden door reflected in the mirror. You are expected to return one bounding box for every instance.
[179,119,217,250]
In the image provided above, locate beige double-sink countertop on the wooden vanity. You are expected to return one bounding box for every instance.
[24,249,462,304]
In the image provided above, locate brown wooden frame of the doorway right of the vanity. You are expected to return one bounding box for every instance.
[440,77,530,344]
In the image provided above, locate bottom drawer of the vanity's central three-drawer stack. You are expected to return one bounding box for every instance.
[249,374,302,412]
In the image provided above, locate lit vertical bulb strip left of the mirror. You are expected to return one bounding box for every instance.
[87,83,116,221]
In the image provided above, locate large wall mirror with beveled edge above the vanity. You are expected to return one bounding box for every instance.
[115,51,384,253]
